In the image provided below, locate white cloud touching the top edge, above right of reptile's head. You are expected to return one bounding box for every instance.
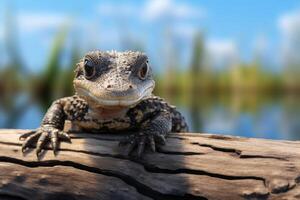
[142,0,204,20]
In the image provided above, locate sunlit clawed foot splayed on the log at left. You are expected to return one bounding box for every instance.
[19,126,71,157]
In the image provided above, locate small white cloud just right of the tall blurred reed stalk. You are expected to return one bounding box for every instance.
[206,39,238,67]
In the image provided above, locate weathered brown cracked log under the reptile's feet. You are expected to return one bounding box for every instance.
[0,130,300,200]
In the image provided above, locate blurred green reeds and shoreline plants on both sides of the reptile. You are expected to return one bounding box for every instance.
[0,23,300,114]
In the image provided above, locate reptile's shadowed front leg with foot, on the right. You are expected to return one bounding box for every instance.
[120,110,172,157]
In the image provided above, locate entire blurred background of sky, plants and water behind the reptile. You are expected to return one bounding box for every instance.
[0,0,300,140]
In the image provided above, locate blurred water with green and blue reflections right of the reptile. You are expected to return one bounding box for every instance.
[173,95,300,140]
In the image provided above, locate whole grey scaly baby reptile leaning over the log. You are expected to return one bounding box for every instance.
[20,51,188,157]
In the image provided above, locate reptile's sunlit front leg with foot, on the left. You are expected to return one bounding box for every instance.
[20,99,70,157]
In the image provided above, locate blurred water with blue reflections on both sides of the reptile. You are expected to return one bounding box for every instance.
[0,95,300,140]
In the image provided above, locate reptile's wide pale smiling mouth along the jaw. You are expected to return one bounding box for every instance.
[76,86,154,107]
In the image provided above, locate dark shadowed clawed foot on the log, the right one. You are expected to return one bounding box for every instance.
[119,133,166,158]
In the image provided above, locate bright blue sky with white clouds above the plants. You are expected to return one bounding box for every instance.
[0,0,300,71]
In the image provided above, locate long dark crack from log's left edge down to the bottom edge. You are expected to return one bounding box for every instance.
[0,156,207,200]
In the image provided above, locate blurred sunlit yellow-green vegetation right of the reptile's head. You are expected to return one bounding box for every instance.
[157,35,300,99]
